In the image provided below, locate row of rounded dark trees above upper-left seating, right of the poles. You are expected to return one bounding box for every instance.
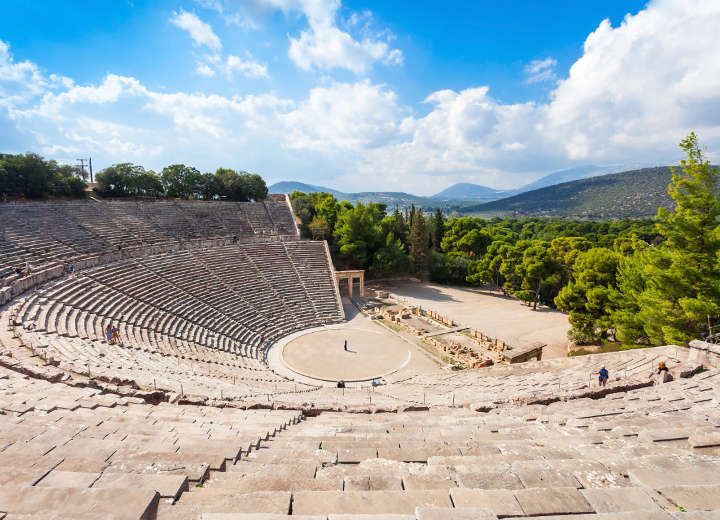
[95,163,268,201]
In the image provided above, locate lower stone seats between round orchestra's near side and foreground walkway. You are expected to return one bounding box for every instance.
[252,346,700,410]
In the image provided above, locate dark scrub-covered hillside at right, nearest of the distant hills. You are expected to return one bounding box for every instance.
[461,167,673,219]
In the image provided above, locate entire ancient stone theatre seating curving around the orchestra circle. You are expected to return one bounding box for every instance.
[0,199,720,520]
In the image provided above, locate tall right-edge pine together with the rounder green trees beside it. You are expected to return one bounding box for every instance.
[555,134,720,345]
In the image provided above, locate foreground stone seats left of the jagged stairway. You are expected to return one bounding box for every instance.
[0,368,301,520]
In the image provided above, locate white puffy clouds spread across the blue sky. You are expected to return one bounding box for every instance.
[0,0,720,193]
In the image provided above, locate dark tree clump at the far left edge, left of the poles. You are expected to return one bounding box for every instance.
[0,153,87,199]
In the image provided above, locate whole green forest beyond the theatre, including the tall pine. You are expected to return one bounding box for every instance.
[291,134,720,345]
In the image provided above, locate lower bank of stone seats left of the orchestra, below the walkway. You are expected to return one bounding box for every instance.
[15,242,342,368]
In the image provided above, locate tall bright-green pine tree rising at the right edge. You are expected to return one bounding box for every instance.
[624,133,720,345]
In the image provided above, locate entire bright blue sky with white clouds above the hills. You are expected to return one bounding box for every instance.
[0,0,720,193]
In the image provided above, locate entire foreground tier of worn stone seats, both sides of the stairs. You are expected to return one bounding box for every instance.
[0,362,720,520]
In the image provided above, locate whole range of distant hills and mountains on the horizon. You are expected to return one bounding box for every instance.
[269,166,672,219]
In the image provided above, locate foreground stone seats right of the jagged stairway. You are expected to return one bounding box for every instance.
[158,370,720,520]
